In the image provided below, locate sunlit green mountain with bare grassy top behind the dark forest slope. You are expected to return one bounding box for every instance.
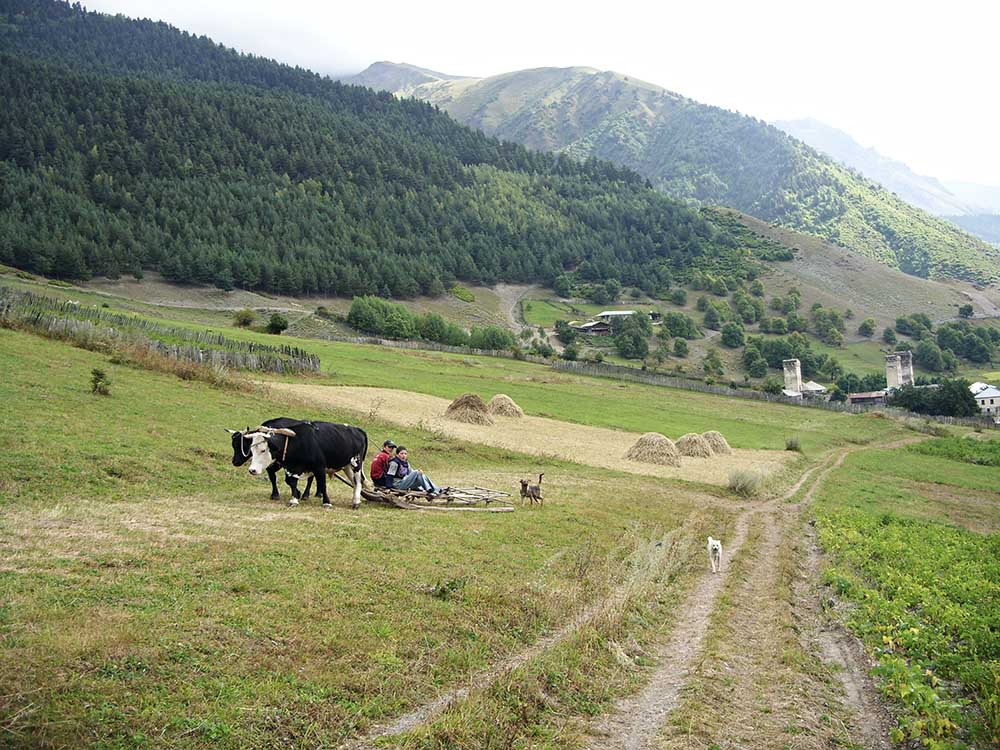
[347,63,1000,281]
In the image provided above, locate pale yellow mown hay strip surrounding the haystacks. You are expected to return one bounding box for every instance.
[270,383,792,486]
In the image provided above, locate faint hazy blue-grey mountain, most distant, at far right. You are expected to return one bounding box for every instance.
[774,118,982,216]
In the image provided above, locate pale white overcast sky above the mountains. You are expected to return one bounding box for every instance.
[83,0,1000,184]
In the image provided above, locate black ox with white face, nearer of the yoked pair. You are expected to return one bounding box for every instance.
[244,422,368,508]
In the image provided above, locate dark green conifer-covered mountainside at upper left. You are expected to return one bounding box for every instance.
[0,0,742,297]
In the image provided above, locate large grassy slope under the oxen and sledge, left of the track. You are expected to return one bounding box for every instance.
[0,330,744,747]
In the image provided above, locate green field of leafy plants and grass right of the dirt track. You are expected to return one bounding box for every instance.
[816,444,1000,748]
